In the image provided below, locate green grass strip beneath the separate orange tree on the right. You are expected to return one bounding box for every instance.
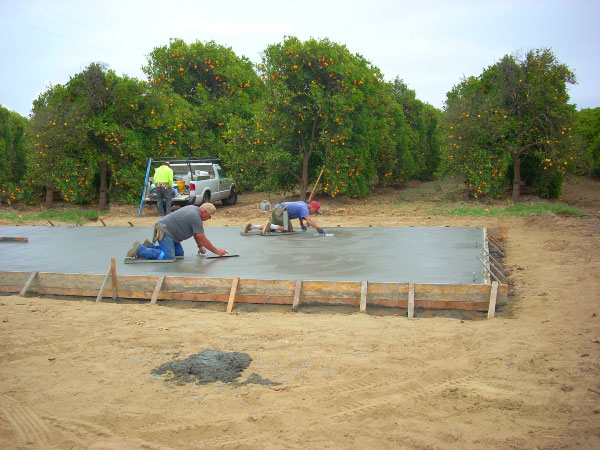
[430,203,583,217]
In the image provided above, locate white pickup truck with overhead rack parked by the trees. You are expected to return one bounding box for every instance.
[144,158,237,206]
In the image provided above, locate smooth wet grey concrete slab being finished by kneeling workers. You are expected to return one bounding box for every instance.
[0,226,484,284]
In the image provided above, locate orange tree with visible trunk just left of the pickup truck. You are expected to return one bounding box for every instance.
[27,64,165,209]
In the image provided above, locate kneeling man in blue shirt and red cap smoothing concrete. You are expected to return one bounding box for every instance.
[244,200,325,234]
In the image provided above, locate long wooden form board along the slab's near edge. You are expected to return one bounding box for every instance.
[0,269,508,311]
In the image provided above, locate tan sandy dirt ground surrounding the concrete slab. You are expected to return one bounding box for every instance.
[0,180,600,449]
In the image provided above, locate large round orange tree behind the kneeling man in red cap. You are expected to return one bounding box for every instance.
[227,37,393,197]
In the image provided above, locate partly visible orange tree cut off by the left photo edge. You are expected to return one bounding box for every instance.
[0,106,27,204]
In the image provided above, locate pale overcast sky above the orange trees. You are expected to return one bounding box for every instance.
[0,0,600,116]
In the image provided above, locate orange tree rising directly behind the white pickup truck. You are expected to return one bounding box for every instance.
[143,39,262,156]
